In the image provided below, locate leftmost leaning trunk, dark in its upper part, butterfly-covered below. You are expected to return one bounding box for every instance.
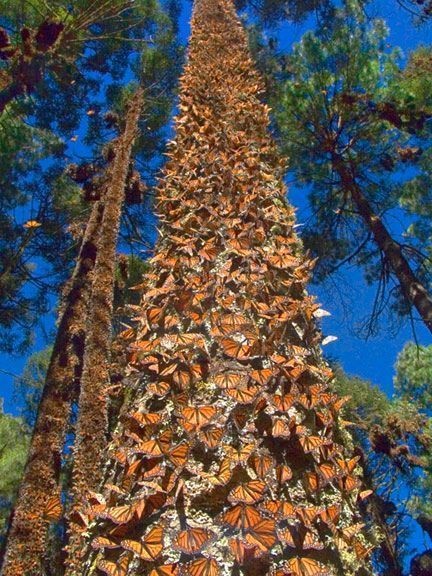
[2,202,103,576]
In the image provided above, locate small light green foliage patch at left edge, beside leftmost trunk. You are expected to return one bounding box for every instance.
[0,404,29,548]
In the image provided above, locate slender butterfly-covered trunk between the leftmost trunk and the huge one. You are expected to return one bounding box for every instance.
[68,88,143,566]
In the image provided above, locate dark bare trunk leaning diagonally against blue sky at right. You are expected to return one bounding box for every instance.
[332,153,432,332]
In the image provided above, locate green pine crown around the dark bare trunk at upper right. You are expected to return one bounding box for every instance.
[273,1,432,328]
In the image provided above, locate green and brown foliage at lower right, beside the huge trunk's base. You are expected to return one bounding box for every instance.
[335,360,432,574]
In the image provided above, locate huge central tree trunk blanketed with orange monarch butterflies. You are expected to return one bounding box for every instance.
[66,0,371,576]
